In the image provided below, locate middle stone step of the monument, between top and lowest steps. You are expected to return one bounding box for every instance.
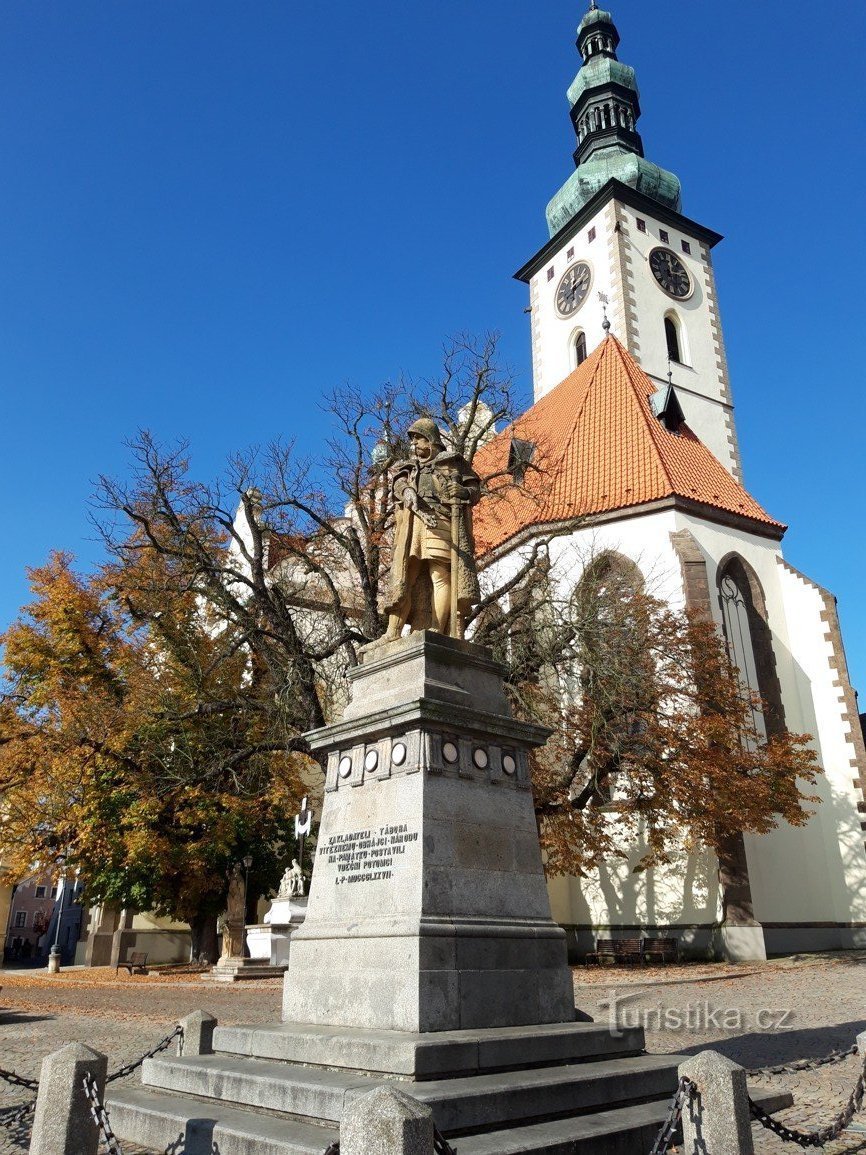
[142,1055,680,1132]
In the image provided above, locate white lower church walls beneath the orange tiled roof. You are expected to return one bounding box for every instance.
[486,508,866,955]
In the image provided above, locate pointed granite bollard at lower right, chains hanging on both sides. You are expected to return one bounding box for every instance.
[679,1051,755,1155]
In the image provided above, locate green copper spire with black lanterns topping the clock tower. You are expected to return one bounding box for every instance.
[547,0,680,237]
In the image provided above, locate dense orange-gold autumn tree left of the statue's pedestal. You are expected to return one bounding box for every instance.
[0,554,301,956]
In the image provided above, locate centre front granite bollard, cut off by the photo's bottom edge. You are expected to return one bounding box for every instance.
[339,1087,433,1155]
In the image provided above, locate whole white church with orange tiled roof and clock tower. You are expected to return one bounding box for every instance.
[475,2,866,960]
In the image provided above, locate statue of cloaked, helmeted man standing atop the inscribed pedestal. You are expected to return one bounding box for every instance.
[386,417,480,638]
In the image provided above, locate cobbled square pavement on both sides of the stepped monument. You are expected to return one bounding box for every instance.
[0,952,866,1155]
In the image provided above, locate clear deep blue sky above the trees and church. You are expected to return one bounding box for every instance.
[0,0,866,690]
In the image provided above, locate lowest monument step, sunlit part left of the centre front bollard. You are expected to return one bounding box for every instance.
[106,1087,338,1155]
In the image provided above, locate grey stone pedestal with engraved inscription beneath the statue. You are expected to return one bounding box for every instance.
[283,633,574,1033]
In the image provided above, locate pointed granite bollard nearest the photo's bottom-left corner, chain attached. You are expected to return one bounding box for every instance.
[30,1043,107,1155]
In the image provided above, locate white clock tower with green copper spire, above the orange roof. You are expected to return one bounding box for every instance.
[516,2,741,480]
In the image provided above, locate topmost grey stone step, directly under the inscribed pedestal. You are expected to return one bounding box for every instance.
[214,1022,643,1079]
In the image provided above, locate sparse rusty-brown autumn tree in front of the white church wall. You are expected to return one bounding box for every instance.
[520,554,819,918]
